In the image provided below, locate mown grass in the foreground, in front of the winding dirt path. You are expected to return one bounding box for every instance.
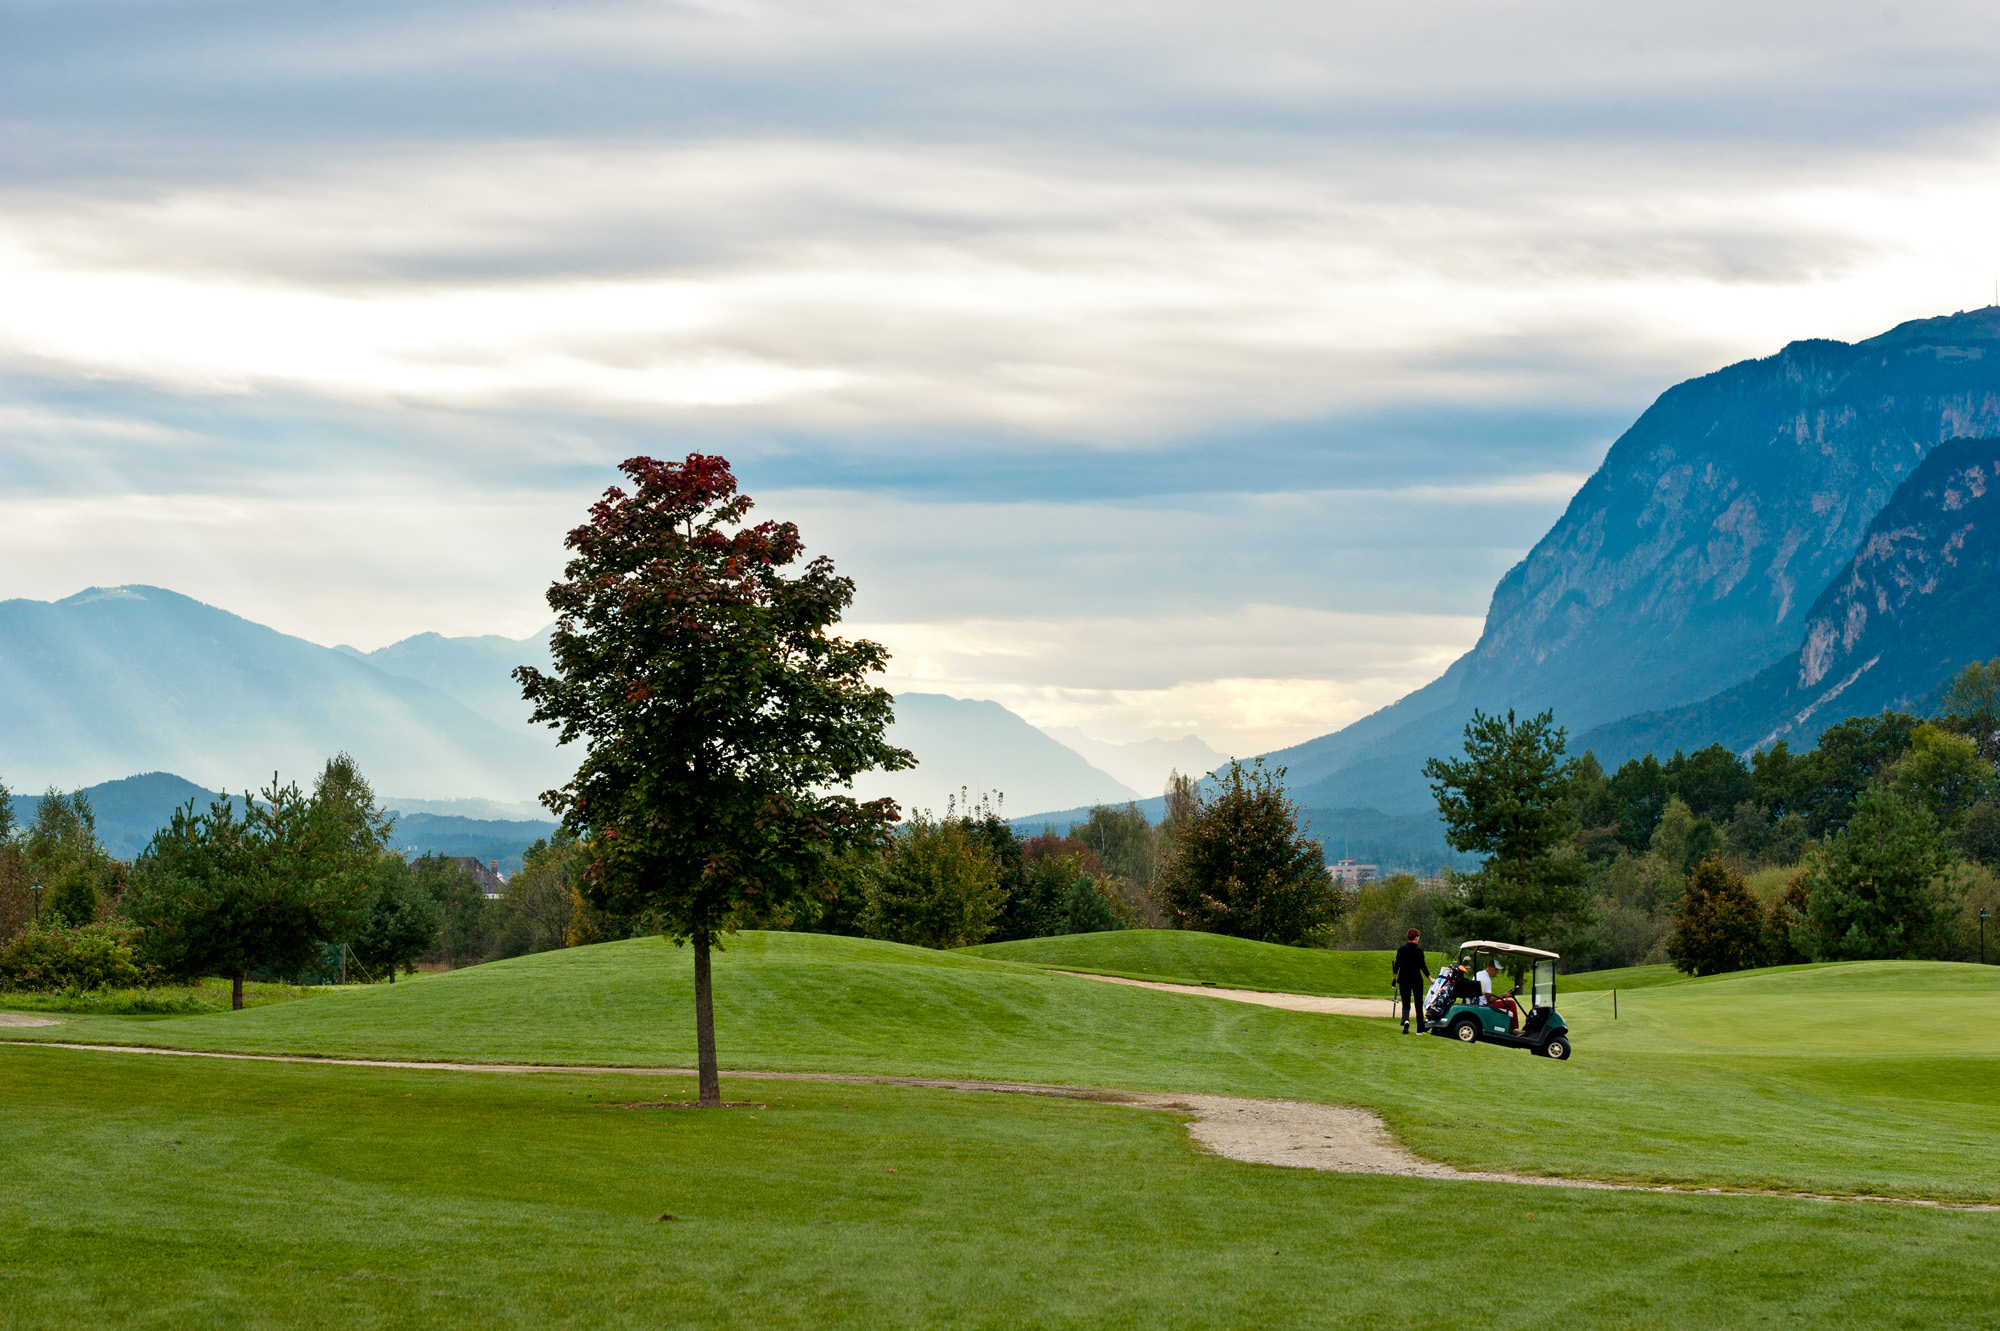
[0,1039,1996,1331]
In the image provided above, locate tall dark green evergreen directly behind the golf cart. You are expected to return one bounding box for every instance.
[1424,711,1592,943]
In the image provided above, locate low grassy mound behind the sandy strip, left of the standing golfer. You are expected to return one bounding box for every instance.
[960,929,1442,997]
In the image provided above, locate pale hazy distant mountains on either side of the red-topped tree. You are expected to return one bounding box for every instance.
[0,586,1184,819]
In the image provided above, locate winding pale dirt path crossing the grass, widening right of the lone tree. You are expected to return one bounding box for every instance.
[0,1039,2000,1211]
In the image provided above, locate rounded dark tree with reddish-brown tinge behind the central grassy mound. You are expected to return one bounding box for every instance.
[1160,759,1348,945]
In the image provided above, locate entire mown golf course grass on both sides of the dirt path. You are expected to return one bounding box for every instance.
[0,931,2000,1327]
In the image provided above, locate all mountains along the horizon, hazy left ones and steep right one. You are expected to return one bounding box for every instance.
[15,308,2000,855]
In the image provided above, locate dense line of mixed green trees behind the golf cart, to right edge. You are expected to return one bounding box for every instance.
[1416,660,2000,973]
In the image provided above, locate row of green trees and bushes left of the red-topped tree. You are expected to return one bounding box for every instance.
[0,753,588,1007]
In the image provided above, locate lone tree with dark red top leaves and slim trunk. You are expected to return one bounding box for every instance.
[514,454,916,1105]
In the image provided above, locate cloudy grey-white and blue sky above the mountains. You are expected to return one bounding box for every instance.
[0,0,2000,753]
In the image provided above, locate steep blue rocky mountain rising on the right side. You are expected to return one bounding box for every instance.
[1272,308,2000,811]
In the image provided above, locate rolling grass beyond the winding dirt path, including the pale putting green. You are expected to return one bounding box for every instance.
[15,933,2000,1201]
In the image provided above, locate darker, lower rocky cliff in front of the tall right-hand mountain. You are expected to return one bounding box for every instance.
[1586,440,2000,757]
